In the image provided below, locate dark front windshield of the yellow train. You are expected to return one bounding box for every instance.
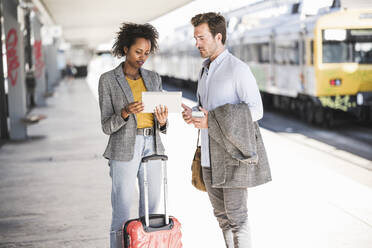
[322,29,372,64]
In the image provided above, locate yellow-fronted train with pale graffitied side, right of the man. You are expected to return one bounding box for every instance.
[229,9,372,126]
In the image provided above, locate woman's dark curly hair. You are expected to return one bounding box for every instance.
[112,22,159,58]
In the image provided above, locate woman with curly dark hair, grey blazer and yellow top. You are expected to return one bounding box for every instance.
[98,23,168,248]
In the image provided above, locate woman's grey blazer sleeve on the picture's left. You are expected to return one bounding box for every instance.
[98,74,127,135]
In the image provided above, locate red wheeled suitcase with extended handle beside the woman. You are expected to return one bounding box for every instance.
[123,155,182,248]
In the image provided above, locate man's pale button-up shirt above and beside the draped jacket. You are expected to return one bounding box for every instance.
[197,49,263,167]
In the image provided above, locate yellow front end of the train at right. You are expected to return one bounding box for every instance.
[314,10,372,124]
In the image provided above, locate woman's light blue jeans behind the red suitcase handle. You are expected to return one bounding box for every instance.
[109,135,162,248]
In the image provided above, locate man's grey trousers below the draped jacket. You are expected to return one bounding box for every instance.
[203,167,251,248]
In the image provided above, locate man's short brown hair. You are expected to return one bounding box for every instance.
[191,12,226,44]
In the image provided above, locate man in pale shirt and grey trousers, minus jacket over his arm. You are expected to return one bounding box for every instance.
[182,13,271,248]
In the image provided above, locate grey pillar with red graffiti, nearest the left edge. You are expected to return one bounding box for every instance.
[2,0,27,140]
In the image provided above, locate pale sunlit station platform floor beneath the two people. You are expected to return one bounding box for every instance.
[0,80,372,248]
